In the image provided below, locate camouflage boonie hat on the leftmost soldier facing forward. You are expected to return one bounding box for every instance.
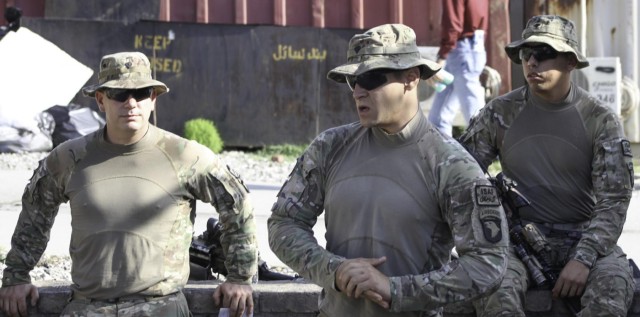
[82,52,169,97]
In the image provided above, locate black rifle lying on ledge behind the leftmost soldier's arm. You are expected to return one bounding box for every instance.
[189,217,298,281]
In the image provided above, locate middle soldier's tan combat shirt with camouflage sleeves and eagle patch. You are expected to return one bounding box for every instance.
[268,112,508,316]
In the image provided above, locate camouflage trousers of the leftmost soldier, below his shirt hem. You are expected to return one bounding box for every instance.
[60,292,191,317]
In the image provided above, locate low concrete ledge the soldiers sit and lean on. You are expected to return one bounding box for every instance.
[0,279,640,317]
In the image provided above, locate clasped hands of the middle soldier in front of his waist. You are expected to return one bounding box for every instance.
[336,257,391,308]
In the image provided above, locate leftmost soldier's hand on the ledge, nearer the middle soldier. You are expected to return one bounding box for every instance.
[213,282,253,317]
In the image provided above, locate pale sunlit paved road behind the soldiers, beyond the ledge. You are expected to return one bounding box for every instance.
[0,171,640,266]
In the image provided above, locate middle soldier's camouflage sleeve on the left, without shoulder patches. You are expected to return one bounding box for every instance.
[268,134,345,289]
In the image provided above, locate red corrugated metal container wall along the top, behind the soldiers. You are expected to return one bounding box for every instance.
[5,0,511,93]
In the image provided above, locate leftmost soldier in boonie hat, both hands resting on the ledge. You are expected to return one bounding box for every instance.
[0,52,258,317]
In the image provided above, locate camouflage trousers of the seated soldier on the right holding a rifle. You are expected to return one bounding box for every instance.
[473,226,635,317]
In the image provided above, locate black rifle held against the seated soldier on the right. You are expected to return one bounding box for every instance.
[485,171,580,315]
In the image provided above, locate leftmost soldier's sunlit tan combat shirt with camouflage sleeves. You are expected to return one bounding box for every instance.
[3,126,257,299]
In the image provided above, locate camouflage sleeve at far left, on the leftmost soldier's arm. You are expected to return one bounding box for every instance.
[2,155,67,286]
